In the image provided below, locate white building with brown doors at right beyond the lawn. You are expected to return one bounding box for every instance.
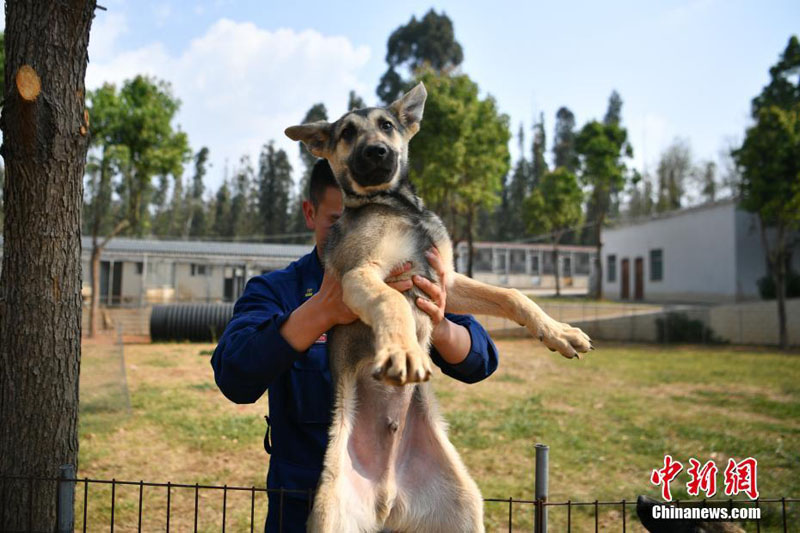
[602,200,800,302]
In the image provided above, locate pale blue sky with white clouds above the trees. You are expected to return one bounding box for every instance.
[6,0,800,195]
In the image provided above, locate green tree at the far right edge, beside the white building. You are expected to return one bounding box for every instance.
[733,36,800,348]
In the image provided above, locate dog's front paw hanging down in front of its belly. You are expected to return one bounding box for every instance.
[372,339,431,385]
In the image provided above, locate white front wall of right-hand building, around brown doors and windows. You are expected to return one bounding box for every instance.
[603,203,736,302]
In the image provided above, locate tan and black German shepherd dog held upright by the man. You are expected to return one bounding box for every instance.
[286,83,591,533]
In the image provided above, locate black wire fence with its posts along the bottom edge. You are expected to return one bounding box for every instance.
[0,444,800,533]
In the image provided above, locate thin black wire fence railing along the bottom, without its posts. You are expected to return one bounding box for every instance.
[0,476,800,533]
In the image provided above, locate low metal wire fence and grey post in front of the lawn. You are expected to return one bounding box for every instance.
[0,444,800,533]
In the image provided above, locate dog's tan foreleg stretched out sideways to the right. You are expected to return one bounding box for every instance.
[447,272,592,358]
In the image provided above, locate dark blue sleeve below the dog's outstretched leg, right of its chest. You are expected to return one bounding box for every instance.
[431,313,497,383]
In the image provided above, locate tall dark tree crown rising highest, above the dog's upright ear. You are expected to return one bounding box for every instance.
[376,9,464,105]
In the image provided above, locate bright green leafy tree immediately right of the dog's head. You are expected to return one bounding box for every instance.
[409,69,510,275]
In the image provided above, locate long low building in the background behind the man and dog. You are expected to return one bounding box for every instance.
[0,237,594,307]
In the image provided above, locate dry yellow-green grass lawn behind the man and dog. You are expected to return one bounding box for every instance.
[76,340,800,531]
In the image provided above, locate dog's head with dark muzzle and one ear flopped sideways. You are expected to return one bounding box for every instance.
[286,83,428,196]
